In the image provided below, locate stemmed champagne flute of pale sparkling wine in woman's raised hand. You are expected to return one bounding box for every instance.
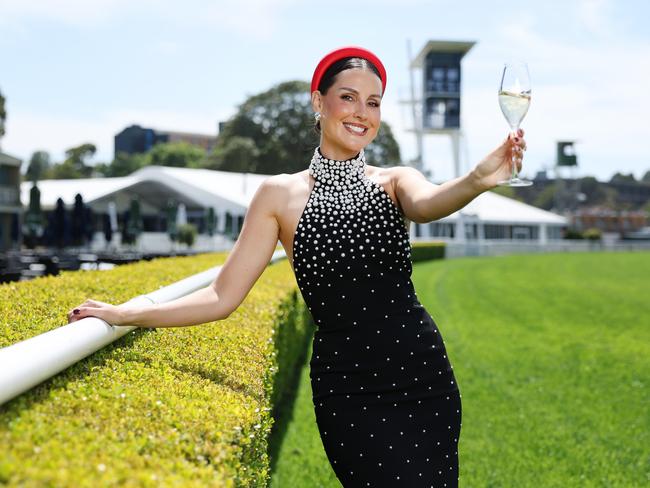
[497,62,533,186]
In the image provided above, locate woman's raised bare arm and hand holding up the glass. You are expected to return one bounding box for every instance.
[394,129,526,224]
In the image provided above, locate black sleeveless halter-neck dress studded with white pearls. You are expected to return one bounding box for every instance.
[293,148,461,488]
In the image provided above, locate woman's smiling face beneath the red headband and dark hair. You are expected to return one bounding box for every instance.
[312,68,382,160]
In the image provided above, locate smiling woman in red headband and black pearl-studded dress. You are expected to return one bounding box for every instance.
[69,47,525,487]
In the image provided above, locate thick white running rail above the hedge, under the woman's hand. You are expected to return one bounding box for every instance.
[0,251,286,405]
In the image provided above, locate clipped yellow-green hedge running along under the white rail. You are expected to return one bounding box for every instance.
[0,254,313,487]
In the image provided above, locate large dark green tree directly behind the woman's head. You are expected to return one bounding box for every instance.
[207,81,400,174]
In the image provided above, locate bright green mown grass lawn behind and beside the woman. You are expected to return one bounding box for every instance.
[271,252,650,488]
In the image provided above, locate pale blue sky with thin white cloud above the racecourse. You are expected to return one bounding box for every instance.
[0,0,650,181]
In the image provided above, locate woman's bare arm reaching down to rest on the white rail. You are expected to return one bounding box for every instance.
[68,175,286,327]
